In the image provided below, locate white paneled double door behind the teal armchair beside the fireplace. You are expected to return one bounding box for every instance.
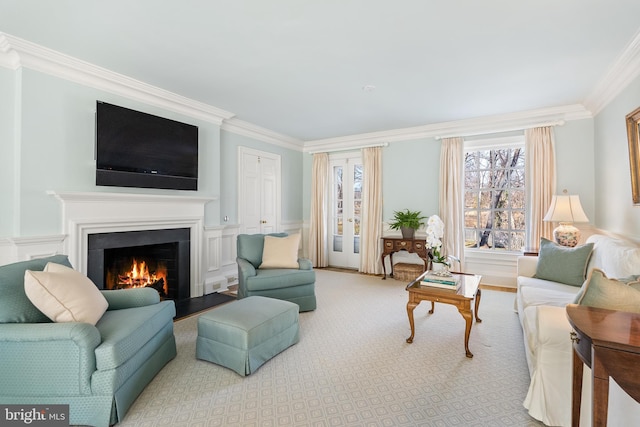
[238,147,280,234]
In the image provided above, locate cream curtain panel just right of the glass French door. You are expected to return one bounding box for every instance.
[360,147,382,274]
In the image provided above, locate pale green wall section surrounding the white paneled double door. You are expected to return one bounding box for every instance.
[220,130,303,224]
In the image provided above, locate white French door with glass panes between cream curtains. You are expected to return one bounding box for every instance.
[329,153,363,269]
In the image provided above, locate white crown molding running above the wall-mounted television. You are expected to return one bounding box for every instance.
[0,33,235,126]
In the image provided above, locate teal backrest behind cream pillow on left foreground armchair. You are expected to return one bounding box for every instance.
[0,255,71,323]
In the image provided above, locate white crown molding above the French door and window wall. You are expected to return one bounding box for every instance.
[304,104,593,152]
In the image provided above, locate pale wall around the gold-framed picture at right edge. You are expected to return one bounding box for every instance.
[595,73,640,239]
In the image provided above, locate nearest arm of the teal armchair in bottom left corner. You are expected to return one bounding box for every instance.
[0,322,101,401]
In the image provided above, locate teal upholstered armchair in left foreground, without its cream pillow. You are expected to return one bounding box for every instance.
[0,255,176,426]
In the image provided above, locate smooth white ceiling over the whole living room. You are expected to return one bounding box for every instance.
[0,0,640,141]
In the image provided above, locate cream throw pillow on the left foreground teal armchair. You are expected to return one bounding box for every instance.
[24,262,109,325]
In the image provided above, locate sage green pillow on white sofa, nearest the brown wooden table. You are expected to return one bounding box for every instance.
[575,268,640,313]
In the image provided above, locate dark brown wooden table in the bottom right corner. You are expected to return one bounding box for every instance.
[567,304,640,426]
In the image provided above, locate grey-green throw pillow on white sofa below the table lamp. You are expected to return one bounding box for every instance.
[534,237,593,286]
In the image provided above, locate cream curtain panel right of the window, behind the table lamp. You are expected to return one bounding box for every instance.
[524,126,556,251]
